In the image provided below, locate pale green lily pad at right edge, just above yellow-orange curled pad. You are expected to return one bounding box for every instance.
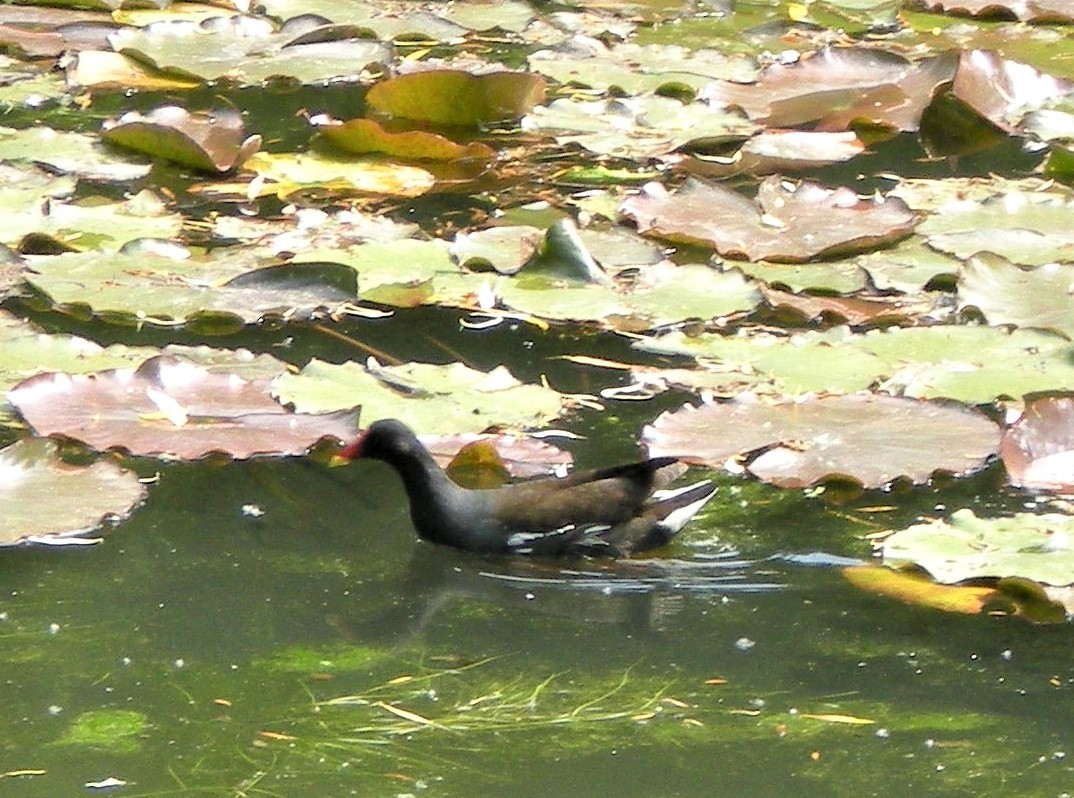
[882,509,1074,586]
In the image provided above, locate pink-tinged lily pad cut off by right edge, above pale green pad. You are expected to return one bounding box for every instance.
[1000,396,1074,493]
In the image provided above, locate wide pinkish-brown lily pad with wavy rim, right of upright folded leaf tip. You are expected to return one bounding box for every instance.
[620,177,917,263]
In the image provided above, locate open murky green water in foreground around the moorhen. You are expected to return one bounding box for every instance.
[6,369,1074,798]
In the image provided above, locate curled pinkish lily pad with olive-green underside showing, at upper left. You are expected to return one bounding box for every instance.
[101,105,261,173]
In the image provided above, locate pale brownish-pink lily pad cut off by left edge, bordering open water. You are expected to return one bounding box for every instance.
[0,438,146,547]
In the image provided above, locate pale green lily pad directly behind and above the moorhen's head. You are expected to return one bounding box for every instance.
[273,359,568,434]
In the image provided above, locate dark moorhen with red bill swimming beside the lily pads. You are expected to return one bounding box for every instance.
[339,419,716,556]
